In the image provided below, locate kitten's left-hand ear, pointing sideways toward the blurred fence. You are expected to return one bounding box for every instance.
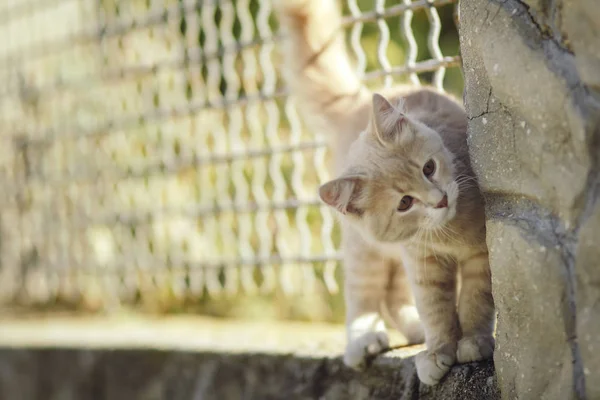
[319,176,365,215]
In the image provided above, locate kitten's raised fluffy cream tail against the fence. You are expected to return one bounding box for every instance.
[275,0,370,137]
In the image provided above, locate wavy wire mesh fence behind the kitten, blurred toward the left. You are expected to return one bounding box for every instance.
[0,0,462,319]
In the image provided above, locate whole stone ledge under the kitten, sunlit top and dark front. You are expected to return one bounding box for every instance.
[0,317,500,400]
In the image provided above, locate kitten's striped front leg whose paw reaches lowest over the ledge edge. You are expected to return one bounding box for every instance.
[404,253,461,385]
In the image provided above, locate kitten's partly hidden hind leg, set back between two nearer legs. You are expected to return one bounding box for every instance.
[385,261,425,344]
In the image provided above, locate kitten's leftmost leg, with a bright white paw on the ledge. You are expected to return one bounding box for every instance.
[344,236,389,369]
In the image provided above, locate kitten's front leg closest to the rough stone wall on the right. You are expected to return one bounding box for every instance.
[456,252,494,363]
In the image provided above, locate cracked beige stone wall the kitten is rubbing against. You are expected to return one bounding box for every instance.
[460,0,600,400]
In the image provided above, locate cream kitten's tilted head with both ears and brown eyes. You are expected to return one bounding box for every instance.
[319,94,459,242]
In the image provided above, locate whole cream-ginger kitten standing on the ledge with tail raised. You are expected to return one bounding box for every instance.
[276,0,494,385]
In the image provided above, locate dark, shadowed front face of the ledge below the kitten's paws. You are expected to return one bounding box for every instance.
[0,348,500,400]
